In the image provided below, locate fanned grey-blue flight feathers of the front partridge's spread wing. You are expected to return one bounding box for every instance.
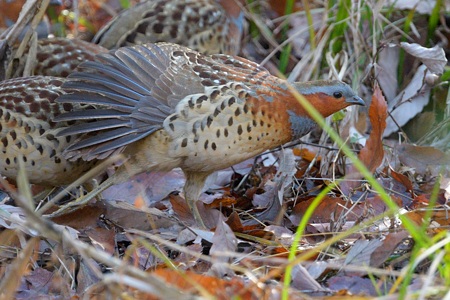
[55,44,203,160]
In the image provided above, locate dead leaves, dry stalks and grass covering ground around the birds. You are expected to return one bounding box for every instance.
[0,0,450,299]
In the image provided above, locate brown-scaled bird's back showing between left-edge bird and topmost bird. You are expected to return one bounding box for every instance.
[13,37,108,77]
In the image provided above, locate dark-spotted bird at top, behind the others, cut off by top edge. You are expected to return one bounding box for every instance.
[93,0,246,55]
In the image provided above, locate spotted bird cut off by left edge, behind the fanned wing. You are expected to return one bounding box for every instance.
[0,76,96,187]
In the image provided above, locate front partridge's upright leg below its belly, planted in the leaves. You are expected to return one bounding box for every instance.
[184,171,211,228]
